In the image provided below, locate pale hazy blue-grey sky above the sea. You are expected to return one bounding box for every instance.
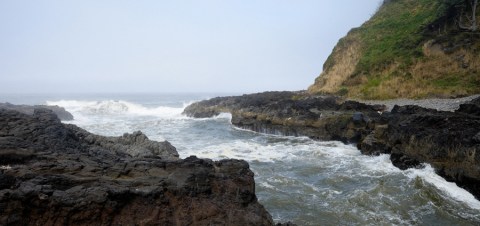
[0,0,382,93]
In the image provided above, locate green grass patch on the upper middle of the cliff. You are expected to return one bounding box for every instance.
[354,0,442,75]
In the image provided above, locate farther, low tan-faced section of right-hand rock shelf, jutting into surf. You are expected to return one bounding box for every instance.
[184,92,384,143]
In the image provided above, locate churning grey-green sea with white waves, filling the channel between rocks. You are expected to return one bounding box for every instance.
[0,94,480,225]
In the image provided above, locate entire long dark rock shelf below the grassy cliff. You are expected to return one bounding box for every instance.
[184,92,480,199]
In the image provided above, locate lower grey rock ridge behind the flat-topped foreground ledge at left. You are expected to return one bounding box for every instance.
[0,108,178,159]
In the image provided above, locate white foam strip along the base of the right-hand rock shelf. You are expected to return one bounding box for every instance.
[206,133,480,209]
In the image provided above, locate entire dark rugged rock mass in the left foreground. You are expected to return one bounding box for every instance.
[0,109,273,225]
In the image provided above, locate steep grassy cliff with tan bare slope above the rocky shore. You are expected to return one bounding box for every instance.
[308,0,480,99]
